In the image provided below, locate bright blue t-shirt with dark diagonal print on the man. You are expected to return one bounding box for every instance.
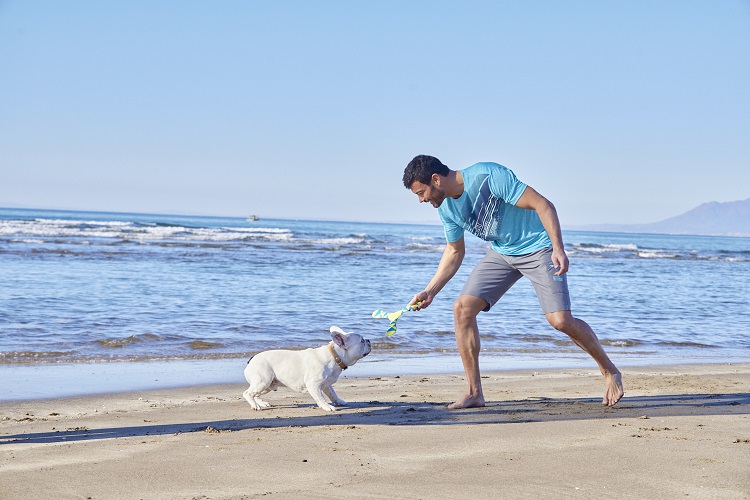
[438,162,552,255]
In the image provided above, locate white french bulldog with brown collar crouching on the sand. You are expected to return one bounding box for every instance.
[242,326,371,411]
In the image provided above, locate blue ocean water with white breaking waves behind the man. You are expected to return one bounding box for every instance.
[0,209,750,400]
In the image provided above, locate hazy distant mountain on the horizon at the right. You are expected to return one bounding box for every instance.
[569,198,750,236]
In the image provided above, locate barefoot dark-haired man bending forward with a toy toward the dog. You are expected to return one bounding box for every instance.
[403,155,623,409]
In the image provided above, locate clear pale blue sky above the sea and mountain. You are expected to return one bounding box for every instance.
[0,0,750,226]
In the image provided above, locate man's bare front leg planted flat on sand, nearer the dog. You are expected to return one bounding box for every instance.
[448,295,487,410]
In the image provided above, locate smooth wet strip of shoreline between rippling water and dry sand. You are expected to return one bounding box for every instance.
[0,353,750,405]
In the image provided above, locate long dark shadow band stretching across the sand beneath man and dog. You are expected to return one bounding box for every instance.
[0,393,750,445]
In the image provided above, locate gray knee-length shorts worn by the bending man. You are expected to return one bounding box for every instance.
[461,248,570,314]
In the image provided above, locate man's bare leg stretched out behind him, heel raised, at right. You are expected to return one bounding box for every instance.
[546,311,625,406]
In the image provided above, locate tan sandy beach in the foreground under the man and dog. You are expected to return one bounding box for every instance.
[0,364,750,499]
